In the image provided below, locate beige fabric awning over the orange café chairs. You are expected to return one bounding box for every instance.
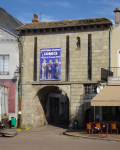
[91,86,120,106]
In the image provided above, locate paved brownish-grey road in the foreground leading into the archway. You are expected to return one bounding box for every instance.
[0,125,120,150]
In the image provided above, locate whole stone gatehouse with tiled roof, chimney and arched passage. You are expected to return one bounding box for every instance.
[17,15,111,128]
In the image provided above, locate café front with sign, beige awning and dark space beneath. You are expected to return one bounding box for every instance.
[91,77,120,121]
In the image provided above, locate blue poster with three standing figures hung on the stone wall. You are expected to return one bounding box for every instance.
[40,48,61,80]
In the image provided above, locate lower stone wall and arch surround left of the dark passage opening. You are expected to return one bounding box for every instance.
[22,85,70,128]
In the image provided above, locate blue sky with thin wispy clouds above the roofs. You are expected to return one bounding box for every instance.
[0,0,120,24]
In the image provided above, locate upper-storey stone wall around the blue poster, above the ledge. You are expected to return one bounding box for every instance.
[23,30,109,82]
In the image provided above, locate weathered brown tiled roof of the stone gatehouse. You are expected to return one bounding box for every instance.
[17,18,111,30]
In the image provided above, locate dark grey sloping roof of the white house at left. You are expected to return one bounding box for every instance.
[0,7,23,35]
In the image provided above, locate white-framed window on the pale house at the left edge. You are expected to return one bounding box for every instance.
[0,55,9,75]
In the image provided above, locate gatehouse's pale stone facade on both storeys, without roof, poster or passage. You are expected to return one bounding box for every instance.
[21,25,109,127]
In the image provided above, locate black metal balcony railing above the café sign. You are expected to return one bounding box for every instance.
[101,67,120,81]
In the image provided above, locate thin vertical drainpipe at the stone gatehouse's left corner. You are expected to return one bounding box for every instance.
[19,37,23,128]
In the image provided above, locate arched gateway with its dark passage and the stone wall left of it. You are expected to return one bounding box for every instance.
[22,85,70,127]
